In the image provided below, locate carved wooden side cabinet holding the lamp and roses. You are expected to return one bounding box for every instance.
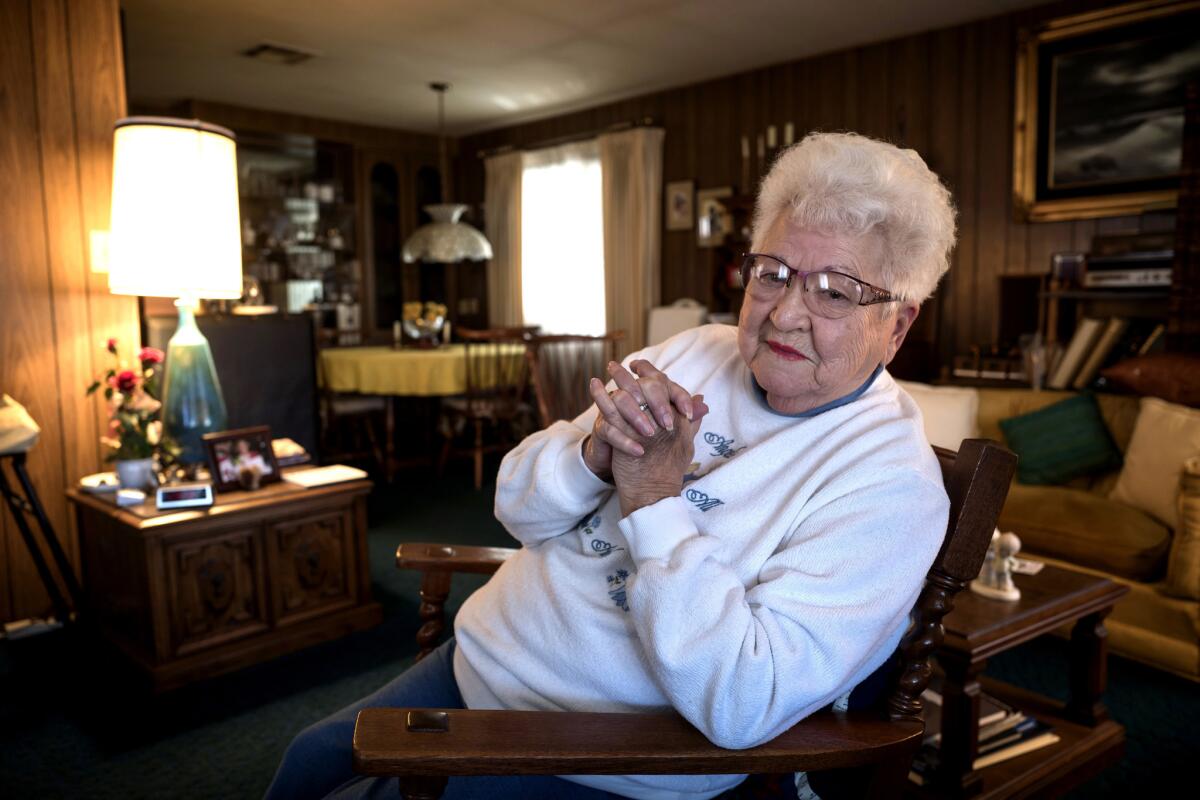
[67,481,383,690]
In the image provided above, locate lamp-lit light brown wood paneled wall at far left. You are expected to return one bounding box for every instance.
[0,0,138,620]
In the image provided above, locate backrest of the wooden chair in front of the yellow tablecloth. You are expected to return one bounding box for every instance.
[458,327,529,416]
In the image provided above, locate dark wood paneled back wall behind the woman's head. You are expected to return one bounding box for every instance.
[458,2,1141,366]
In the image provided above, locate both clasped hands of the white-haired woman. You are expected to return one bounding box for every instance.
[583,359,708,516]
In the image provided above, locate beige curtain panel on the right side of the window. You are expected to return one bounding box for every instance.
[598,128,664,356]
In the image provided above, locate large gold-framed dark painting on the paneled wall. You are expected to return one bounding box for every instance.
[1013,0,1200,222]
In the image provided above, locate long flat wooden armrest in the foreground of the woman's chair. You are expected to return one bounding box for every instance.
[354,708,924,776]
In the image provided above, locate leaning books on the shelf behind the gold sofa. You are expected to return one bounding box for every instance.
[1046,317,1165,389]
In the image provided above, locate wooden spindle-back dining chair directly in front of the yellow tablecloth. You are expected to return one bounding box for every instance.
[438,327,535,489]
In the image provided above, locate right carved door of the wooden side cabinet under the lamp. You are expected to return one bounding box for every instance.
[266,506,359,626]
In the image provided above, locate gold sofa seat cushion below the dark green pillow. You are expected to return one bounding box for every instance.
[1000,483,1171,581]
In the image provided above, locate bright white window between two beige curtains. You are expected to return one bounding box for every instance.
[521,142,607,335]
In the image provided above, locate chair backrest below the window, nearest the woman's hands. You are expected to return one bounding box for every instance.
[529,331,625,428]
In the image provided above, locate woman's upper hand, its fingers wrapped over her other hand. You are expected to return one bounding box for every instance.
[583,359,695,481]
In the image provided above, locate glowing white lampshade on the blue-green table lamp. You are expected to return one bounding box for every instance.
[108,116,241,300]
